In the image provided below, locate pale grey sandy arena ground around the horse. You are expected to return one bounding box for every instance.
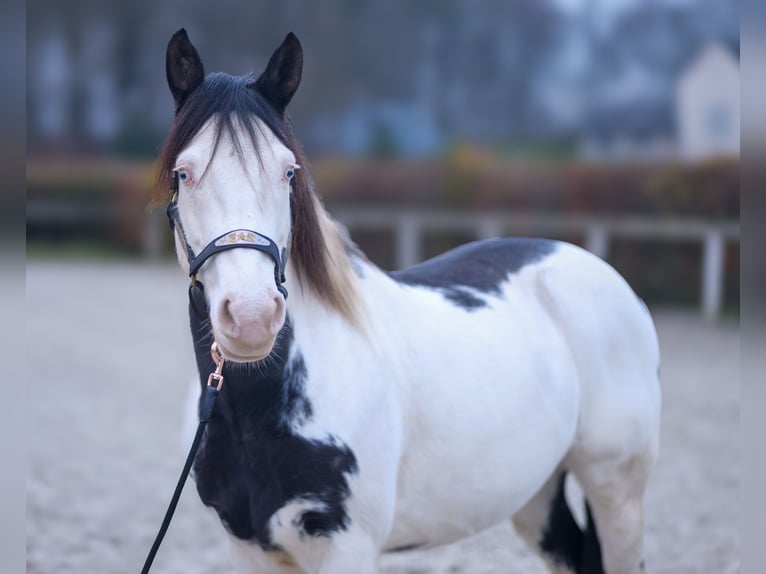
[26,263,740,574]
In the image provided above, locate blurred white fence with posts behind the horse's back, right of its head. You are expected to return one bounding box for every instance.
[332,208,740,319]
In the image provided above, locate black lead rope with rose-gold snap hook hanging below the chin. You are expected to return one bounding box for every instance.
[141,343,224,574]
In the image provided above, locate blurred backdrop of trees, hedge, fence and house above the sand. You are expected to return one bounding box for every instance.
[27,0,739,315]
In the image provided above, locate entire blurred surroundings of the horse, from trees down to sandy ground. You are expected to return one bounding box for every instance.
[26,0,740,574]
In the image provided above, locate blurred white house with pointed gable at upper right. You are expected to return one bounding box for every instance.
[675,42,740,161]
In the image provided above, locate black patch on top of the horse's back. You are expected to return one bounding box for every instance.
[390,237,557,311]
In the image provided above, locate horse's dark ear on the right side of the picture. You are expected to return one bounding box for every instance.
[254,32,303,114]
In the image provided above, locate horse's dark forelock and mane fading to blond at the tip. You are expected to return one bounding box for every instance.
[152,73,359,324]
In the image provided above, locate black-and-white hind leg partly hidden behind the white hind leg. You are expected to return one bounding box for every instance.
[512,470,583,574]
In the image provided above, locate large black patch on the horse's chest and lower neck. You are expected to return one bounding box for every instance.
[189,308,358,550]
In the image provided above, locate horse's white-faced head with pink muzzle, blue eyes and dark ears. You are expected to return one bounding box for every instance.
[161,30,306,362]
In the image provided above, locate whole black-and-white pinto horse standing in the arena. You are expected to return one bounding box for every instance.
[155,29,661,574]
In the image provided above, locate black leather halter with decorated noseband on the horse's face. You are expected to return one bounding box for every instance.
[167,171,287,308]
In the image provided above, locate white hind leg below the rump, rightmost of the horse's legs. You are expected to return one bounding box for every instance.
[572,449,655,574]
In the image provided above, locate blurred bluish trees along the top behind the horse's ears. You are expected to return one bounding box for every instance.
[28,0,738,155]
